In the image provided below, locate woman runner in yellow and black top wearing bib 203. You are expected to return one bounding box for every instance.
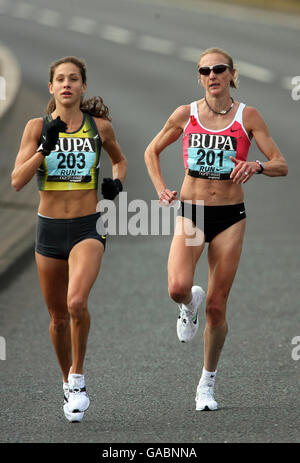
[12,56,127,421]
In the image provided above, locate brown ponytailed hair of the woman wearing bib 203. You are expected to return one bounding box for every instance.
[46,56,111,121]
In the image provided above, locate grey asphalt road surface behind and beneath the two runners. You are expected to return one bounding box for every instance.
[0,0,300,444]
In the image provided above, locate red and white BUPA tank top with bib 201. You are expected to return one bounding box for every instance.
[183,101,251,180]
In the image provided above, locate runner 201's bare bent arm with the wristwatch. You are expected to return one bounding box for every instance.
[244,107,288,177]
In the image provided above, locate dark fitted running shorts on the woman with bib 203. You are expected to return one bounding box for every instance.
[35,212,106,260]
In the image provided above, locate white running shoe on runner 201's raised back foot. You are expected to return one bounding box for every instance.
[177,286,205,342]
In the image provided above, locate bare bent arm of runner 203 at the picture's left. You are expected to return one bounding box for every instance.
[11,118,44,191]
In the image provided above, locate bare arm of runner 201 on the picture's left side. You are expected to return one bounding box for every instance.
[145,105,190,199]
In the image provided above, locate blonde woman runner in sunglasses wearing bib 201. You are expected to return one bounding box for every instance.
[145,48,288,410]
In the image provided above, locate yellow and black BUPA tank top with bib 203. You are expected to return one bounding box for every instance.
[37,113,102,191]
